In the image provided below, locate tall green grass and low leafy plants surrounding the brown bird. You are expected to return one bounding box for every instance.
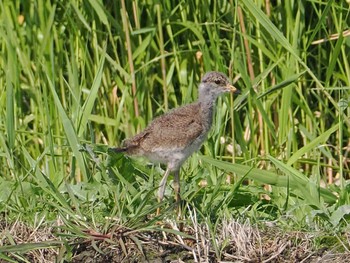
[0,0,350,261]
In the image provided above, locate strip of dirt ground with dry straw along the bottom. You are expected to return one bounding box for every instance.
[0,222,350,263]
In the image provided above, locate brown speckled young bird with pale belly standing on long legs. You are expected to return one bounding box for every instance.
[110,71,238,216]
